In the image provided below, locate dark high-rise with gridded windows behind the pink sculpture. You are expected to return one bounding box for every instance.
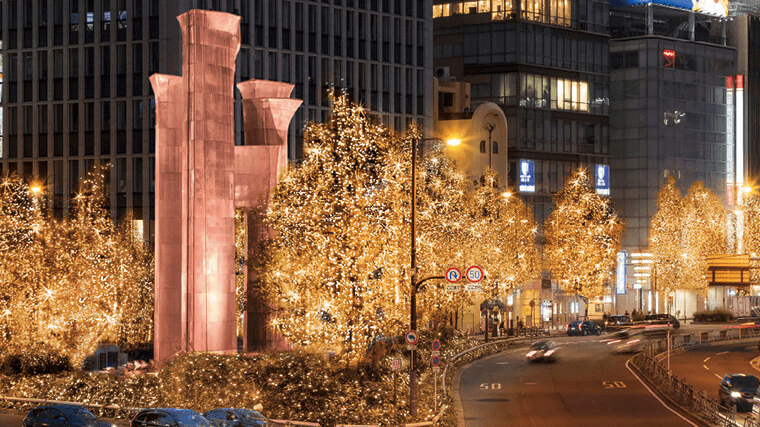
[0,0,432,240]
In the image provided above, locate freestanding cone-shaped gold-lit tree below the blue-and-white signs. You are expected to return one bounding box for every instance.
[545,170,624,308]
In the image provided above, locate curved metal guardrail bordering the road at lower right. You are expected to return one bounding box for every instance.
[631,326,760,427]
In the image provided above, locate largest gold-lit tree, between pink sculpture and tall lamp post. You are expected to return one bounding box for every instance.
[260,97,418,360]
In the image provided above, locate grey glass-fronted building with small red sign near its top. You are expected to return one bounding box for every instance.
[610,5,736,253]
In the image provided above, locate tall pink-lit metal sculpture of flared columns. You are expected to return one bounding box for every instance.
[150,10,301,364]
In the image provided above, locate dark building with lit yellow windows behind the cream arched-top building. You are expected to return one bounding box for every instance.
[433,0,609,231]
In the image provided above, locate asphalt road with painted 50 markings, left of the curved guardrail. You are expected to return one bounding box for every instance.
[454,335,693,427]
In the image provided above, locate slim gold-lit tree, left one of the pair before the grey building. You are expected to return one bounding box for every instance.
[649,176,685,293]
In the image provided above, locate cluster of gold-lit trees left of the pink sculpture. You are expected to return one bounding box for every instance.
[0,170,153,364]
